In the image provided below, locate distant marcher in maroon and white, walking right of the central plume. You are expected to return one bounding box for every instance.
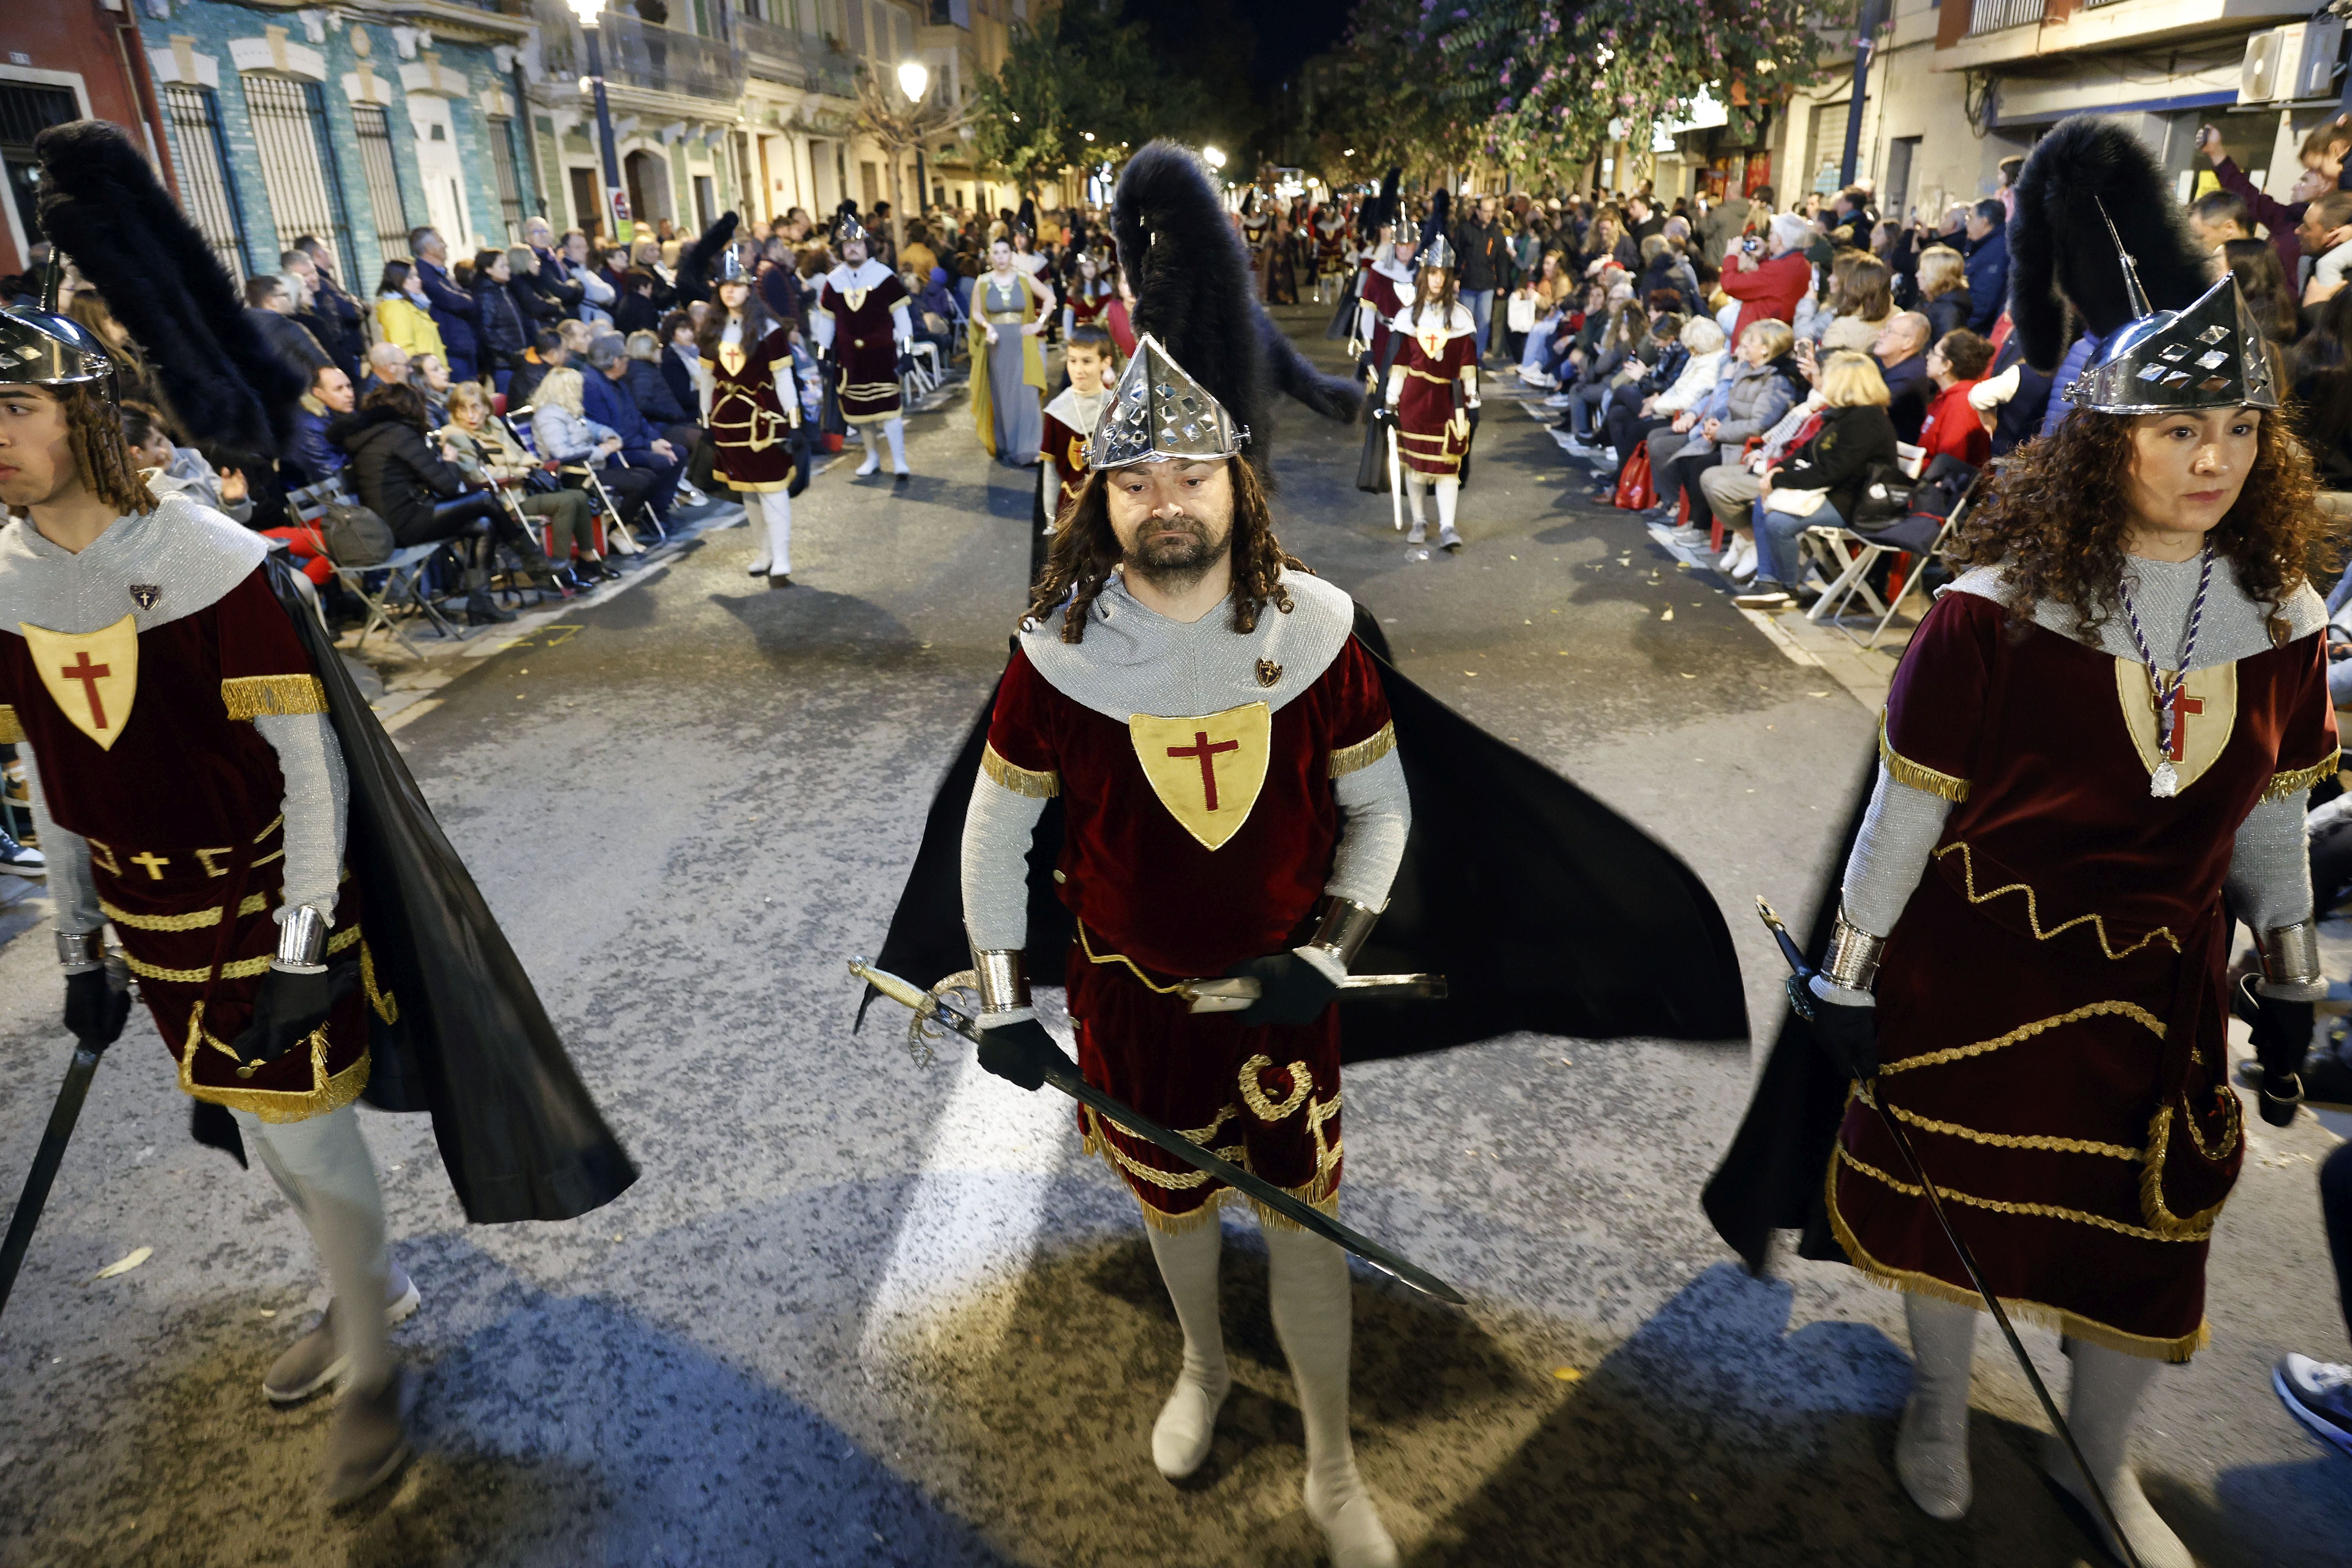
[1381,221,1479,550]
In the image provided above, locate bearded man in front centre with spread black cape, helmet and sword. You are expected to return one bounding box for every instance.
[880,141,1743,1568]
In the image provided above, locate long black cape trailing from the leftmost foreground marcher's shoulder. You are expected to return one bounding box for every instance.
[195,557,637,1225]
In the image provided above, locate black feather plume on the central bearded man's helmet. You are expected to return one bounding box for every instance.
[1110,141,1362,479]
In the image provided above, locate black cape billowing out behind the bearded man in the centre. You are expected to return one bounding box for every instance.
[868,604,1748,1063]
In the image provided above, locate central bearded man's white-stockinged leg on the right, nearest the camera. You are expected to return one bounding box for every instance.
[1265,1225,1397,1568]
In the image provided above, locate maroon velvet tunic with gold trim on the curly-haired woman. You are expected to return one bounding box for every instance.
[1828,592,2336,1361]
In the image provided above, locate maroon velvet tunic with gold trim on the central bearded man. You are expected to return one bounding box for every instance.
[985,637,1390,1229]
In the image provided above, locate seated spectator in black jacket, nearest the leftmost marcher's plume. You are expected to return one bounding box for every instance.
[327,386,555,625]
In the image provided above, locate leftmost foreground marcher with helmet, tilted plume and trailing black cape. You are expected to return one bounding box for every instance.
[0,120,635,1502]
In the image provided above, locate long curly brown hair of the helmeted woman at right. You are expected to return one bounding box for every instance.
[1950,409,2333,644]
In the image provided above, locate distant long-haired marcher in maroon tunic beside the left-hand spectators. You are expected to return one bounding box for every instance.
[694,236,809,588]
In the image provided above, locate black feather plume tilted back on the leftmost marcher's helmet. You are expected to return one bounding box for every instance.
[33,120,310,458]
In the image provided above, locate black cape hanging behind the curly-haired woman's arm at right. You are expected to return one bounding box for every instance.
[1698,750,1877,1274]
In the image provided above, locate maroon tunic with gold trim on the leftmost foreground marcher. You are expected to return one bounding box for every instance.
[0,569,393,1122]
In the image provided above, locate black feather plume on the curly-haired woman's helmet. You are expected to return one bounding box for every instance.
[2009,115,2213,372]
